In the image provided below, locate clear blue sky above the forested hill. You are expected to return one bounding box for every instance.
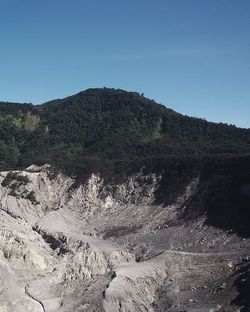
[0,0,250,127]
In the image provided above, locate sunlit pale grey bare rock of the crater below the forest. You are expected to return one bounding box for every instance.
[0,165,249,312]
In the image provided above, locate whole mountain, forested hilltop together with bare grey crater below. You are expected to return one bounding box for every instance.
[0,88,250,312]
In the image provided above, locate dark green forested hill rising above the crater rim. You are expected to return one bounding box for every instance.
[0,88,250,173]
